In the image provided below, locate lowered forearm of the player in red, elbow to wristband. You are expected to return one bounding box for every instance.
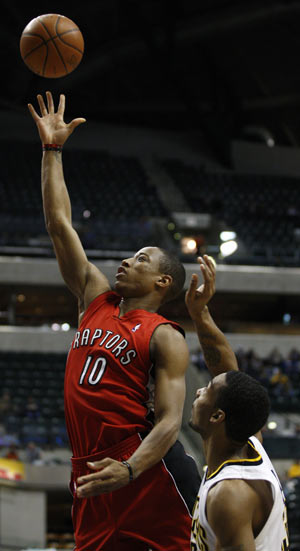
[128,419,179,478]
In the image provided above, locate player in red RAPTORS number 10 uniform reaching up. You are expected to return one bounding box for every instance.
[28,92,220,551]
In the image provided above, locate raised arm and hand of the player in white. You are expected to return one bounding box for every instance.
[185,255,238,377]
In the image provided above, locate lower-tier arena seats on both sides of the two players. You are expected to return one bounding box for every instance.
[0,350,300,446]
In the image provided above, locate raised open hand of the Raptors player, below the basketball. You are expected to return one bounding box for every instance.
[28,92,85,145]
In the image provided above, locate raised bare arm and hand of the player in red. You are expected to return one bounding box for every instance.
[28,92,109,311]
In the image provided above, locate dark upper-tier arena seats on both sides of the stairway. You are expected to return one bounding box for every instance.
[0,144,300,267]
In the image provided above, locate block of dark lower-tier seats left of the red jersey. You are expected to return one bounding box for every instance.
[0,352,68,447]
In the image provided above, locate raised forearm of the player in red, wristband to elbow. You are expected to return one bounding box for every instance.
[41,151,71,230]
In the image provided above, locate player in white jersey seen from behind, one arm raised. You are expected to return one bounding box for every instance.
[186,284,288,551]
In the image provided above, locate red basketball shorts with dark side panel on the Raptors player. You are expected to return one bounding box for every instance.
[71,435,200,551]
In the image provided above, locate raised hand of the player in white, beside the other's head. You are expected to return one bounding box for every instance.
[185,255,216,319]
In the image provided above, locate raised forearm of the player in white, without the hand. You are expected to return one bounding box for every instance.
[193,306,238,377]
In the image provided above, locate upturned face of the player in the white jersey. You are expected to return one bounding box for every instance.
[189,373,225,437]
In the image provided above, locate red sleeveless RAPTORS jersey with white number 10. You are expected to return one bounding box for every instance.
[65,291,182,457]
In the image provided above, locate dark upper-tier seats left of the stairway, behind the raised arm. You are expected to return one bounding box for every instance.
[0,144,166,255]
